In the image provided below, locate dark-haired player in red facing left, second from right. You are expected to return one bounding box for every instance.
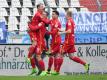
[47,11,63,75]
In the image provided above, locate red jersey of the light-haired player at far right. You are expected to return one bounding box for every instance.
[64,18,75,45]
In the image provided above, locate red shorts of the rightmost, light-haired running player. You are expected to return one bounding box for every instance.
[62,44,76,54]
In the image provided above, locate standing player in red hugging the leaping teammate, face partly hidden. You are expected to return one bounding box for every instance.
[35,11,49,76]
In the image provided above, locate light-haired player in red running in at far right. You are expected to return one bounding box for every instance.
[61,11,89,72]
